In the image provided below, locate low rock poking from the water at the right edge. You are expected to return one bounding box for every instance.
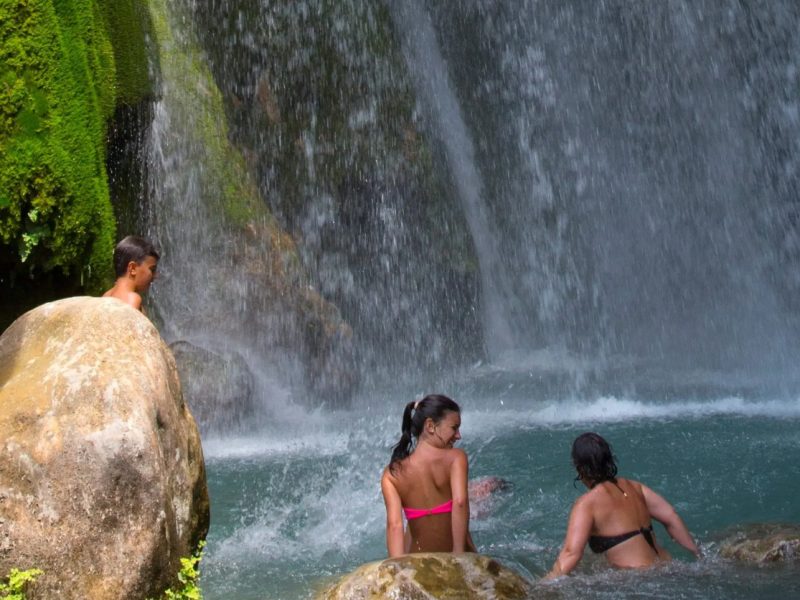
[719,523,800,564]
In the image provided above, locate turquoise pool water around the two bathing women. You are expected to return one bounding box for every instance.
[198,364,800,600]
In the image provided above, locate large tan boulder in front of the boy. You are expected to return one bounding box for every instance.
[0,298,209,600]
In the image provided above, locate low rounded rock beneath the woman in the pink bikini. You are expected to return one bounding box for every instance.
[317,553,531,600]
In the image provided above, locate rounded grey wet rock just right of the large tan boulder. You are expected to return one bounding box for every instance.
[169,341,255,433]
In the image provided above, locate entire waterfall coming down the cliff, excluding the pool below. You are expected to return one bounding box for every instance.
[138,0,800,418]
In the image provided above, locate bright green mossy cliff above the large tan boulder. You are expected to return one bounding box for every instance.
[0,0,149,324]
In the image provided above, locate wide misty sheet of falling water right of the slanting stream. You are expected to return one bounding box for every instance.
[432,1,797,382]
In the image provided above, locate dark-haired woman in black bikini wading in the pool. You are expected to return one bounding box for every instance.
[546,433,698,579]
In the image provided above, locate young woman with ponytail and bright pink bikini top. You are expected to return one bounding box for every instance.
[381,395,475,557]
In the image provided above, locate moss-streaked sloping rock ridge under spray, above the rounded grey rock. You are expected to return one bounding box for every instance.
[141,0,356,406]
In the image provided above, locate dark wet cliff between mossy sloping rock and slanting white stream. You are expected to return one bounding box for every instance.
[190,0,481,377]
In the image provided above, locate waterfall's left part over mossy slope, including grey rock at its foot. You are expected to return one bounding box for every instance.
[145,0,362,432]
